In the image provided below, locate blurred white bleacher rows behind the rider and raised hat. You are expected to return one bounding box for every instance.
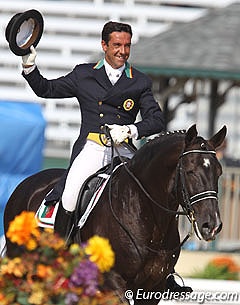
[0,0,233,158]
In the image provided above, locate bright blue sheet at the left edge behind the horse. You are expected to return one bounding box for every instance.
[0,100,46,236]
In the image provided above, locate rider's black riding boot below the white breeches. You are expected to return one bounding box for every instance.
[54,201,73,244]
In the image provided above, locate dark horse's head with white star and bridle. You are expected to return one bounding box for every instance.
[178,125,227,240]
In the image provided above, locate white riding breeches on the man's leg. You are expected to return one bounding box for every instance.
[62,140,133,212]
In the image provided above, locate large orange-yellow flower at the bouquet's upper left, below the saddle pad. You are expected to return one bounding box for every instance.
[7,211,40,250]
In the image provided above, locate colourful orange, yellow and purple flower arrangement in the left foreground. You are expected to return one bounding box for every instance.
[0,212,127,305]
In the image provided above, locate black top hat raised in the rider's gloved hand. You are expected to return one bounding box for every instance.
[5,10,43,56]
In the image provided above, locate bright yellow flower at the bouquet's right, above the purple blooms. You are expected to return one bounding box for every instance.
[85,235,115,272]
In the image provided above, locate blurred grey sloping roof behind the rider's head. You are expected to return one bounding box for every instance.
[131,3,240,80]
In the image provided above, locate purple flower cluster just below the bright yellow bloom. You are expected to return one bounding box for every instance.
[69,260,98,296]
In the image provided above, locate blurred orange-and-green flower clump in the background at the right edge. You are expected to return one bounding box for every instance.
[191,256,240,280]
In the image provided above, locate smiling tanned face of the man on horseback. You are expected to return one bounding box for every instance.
[102,32,131,69]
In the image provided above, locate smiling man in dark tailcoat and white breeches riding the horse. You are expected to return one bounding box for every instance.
[22,21,164,237]
